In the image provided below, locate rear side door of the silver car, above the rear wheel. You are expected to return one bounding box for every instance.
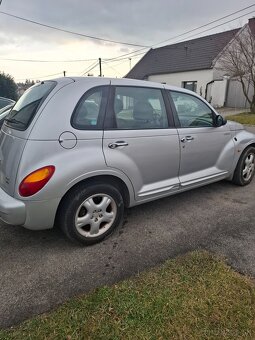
[103,85,180,201]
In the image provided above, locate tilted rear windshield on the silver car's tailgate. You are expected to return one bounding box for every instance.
[5,81,56,131]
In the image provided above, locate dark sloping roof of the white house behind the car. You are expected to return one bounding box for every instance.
[126,28,240,79]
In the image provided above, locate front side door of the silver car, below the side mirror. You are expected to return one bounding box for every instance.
[168,91,234,187]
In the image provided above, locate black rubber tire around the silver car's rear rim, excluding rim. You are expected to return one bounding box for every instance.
[61,184,124,245]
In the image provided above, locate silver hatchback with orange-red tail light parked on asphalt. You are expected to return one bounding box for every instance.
[0,77,255,245]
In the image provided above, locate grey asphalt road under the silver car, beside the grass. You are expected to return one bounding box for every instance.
[0,181,255,327]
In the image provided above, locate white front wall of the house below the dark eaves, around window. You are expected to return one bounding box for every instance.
[148,69,213,97]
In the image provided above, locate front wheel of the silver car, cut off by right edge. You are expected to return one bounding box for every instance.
[232,147,255,186]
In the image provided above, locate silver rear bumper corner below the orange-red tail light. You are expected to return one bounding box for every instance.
[0,188,26,225]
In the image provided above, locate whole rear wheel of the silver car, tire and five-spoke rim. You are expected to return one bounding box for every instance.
[58,184,124,245]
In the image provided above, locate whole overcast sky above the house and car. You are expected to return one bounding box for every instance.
[0,0,255,81]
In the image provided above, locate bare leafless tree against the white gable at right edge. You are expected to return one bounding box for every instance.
[216,24,255,113]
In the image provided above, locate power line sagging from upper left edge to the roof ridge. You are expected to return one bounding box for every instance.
[0,11,147,47]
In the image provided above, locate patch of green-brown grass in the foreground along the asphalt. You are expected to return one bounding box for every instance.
[0,252,255,340]
